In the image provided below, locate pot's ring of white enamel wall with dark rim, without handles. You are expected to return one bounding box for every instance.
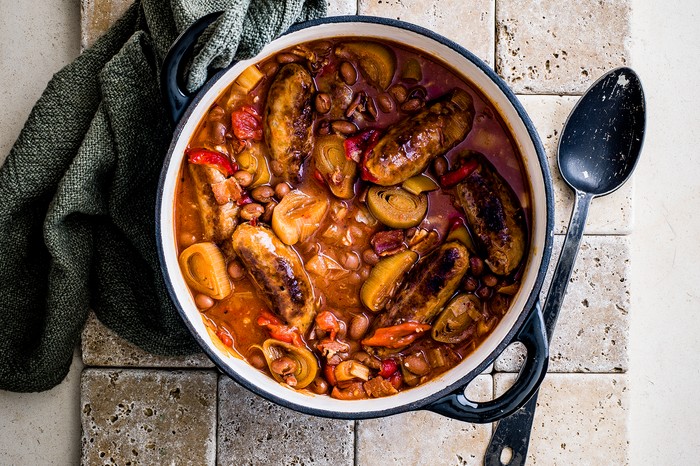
[157,16,553,419]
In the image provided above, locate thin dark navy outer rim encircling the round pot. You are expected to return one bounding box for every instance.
[156,15,554,420]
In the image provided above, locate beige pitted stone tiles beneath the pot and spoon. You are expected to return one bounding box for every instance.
[81,0,633,465]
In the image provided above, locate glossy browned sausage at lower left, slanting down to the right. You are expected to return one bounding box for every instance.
[231,223,316,334]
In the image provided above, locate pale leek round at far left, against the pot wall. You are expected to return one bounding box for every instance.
[179,242,231,299]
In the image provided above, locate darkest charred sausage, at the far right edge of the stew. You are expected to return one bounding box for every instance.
[455,151,527,275]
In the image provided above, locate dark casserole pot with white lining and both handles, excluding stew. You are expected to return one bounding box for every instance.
[156,14,553,422]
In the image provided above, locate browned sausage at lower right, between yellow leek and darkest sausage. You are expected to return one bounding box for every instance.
[373,241,469,329]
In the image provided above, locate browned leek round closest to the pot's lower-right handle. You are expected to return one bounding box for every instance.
[432,294,481,343]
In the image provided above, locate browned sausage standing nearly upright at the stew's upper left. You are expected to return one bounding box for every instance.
[264,63,314,182]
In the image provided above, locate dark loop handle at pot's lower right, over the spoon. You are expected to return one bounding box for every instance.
[425,301,549,423]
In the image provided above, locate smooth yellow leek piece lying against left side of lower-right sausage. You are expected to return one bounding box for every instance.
[360,250,418,312]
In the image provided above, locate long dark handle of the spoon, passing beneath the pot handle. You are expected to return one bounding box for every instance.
[484,190,593,466]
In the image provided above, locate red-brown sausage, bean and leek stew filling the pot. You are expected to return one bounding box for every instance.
[175,38,530,399]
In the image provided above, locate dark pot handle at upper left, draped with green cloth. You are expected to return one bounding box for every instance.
[160,11,222,123]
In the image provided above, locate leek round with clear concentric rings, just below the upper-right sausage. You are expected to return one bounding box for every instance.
[367,186,428,228]
